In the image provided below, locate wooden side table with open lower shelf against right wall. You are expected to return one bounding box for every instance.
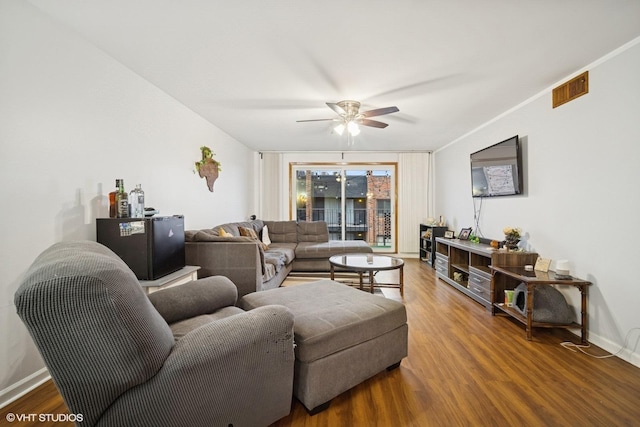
[491,266,591,344]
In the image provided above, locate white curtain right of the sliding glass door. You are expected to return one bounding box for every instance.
[397,153,433,253]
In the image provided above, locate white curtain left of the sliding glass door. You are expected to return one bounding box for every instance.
[258,153,288,221]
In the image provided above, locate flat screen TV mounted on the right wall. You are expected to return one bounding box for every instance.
[471,135,522,197]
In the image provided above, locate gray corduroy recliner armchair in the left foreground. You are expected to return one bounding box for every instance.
[15,241,294,427]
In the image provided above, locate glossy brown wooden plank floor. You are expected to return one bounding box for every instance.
[5,259,640,427]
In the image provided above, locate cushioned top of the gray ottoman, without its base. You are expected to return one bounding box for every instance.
[239,280,407,362]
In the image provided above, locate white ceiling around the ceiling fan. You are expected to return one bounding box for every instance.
[30,0,640,151]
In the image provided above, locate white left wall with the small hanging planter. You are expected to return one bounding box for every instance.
[0,1,254,405]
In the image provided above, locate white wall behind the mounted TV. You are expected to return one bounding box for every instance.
[435,39,640,366]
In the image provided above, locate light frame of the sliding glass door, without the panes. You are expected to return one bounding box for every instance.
[289,162,398,253]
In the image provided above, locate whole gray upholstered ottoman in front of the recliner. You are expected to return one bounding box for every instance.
[239,280,408,414]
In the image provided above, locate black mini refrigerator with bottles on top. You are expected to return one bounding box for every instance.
[96,215,185,280]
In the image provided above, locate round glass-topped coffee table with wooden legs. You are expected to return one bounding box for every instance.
[329,253,404,295]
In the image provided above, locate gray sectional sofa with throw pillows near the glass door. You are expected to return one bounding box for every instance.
[185,219,373,297]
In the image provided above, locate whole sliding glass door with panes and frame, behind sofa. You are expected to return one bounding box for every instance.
[290,163,397,252]
